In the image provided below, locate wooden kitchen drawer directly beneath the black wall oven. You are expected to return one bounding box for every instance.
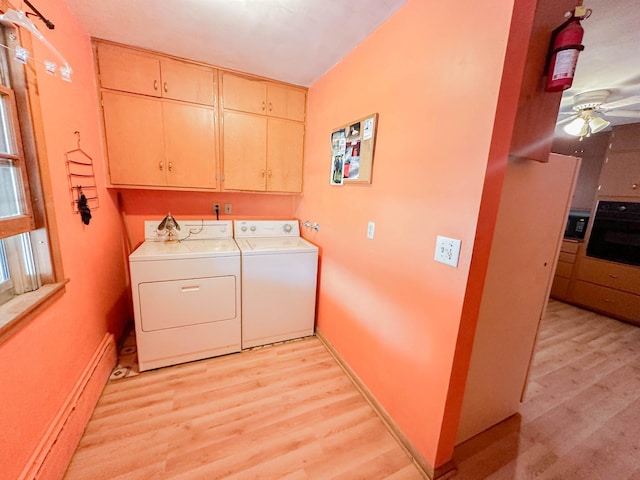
[577,257,640,295]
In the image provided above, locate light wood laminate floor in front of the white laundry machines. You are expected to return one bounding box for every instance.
[65,337,424,480]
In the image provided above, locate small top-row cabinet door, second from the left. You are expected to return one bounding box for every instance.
[160,58,215,106]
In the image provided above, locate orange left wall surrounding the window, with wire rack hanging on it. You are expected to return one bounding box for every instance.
[0,0,129,479]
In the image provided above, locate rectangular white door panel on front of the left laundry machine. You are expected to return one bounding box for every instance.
[138,276,237,332]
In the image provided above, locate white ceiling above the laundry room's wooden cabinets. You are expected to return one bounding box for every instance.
[62,0,406,86]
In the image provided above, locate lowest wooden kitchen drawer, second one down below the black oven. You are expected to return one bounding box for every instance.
[569,281,640,323]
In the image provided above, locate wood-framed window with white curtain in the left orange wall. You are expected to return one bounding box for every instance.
[0,22,64,332]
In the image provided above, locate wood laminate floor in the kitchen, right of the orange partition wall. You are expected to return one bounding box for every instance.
[453,300,640,480]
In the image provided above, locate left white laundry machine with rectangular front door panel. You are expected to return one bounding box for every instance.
[129,220,241,371]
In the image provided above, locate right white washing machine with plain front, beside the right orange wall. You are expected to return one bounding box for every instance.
[234,220,318,348]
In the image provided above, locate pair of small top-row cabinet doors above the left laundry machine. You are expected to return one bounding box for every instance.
[97,43,216,106]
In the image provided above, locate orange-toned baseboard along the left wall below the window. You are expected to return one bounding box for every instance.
[19,333,117,480]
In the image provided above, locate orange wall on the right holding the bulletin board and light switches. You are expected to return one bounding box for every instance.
[296,0,524,467]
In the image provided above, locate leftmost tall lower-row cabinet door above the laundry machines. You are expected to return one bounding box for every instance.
[102,91,166,186]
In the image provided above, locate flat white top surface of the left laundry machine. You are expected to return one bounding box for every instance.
[129,238,240,262]
